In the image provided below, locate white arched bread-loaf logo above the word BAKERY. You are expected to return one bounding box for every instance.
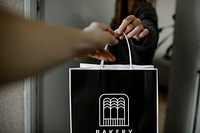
[99,93,129,127]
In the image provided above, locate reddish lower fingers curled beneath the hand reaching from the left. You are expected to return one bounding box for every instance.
[88,49,116,62]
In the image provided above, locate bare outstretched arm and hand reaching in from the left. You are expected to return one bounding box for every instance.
[0,7,118,85]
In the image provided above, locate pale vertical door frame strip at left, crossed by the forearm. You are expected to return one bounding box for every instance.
[24,0,40,133]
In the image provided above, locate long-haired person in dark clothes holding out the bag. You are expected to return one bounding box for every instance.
[109,0,158,65]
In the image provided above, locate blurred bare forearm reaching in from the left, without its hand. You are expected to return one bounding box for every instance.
[0,8,96,81]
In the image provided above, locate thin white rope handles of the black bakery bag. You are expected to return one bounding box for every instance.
[100,33,133,69]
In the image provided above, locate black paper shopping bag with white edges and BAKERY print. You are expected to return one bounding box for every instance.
[70,65,158,133]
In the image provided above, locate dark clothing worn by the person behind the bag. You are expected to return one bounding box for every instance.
[109,4,158,65]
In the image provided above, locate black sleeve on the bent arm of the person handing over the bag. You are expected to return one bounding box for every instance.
[129,4,159,64]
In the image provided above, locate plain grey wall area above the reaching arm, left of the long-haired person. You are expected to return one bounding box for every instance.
[41,0,115,28]
